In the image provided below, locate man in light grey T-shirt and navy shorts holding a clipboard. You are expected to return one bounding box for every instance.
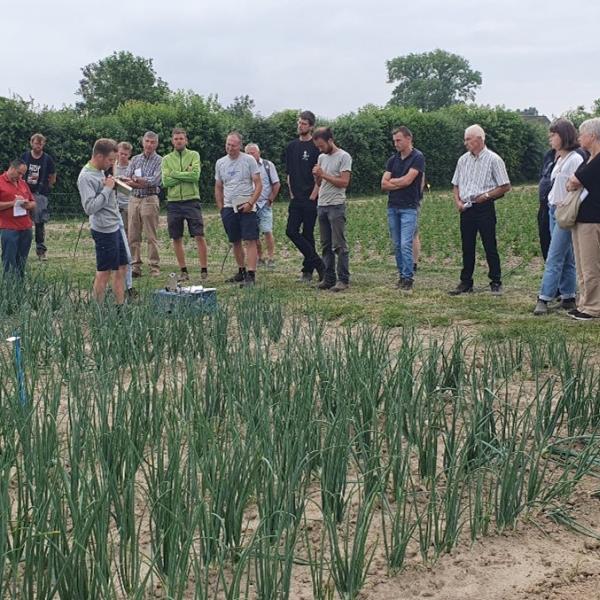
[215,131,262,287]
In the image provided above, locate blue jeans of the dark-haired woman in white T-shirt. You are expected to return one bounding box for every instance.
[539,206,577,302]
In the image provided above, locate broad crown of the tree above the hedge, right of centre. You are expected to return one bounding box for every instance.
[386,48,481,111]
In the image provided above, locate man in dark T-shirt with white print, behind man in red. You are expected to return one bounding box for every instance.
[21,133,56,260]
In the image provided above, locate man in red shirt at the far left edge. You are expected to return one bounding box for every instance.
[0,159,35,279]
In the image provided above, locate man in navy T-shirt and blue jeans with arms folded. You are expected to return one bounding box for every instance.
[381,126,425,292]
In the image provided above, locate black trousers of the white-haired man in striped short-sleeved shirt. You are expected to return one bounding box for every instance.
[460,202,502,286]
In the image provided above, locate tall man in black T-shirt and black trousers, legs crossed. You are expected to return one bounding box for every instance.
[285,110,325,283]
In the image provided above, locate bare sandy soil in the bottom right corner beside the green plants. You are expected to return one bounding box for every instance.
[356,480,600,600]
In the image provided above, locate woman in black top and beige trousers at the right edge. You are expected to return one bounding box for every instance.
[567,117,600,321]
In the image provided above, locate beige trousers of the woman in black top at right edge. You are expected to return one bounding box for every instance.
[573,223,600,317]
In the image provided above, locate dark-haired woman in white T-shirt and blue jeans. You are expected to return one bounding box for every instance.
[533,119,583,315]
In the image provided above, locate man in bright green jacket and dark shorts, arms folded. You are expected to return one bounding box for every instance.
[162,127,208,282]
